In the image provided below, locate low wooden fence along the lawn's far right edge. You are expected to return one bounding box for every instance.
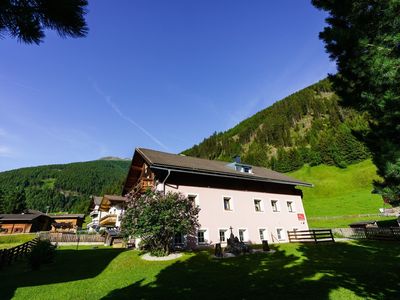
[333,227,400,241]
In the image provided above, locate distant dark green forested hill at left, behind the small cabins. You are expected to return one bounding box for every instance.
[0,159,130,213]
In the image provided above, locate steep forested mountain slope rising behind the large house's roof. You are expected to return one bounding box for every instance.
[183,79,369,172]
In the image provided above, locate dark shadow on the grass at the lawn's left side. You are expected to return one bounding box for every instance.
[0,249,123,299]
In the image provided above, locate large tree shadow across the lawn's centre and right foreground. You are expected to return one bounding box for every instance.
[105,242,400,299]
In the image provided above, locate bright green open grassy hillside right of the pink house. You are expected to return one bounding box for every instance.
[289,160,394,227]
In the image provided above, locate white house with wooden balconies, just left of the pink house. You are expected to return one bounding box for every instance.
[98,195,128,229]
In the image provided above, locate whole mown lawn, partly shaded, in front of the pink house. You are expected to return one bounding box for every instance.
[0,242,400,299]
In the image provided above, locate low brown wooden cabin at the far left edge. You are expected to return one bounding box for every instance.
[0,211,52,234]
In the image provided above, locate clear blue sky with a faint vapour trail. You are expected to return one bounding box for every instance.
[0,0,335,171]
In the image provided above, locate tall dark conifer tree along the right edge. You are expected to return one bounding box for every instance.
[312,0,400,204]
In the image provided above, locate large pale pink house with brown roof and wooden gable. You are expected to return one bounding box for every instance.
[123,148,312,246]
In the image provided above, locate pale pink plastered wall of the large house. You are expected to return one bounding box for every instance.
[158,185,308,246]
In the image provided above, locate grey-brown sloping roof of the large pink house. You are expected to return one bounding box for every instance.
[136,148,313,187]
